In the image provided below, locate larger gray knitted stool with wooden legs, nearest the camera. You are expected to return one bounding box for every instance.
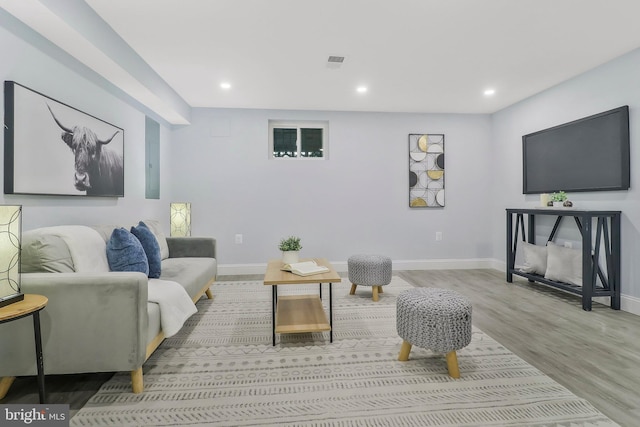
[396,288,471,378]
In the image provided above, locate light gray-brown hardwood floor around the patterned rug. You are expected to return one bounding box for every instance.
[0,270,640,427]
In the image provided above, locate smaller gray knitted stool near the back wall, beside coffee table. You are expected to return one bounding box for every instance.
[347,255,391,301]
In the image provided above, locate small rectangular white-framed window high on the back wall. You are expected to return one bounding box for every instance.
[269,120,329,159]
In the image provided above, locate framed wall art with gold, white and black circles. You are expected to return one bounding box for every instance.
[409,133,444,208]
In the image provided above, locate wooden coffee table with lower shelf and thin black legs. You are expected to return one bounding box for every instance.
[264,258,342,345]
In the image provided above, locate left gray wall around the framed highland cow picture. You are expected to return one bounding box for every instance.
[0,18,171,231]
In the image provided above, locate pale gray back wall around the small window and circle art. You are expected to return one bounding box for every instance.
[170,109,492,268]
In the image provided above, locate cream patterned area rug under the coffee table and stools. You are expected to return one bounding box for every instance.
[71,276,617,427]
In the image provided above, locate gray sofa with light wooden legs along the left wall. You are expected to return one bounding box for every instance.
[0,221,217,398]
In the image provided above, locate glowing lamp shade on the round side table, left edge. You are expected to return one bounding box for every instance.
[0,205,24,307]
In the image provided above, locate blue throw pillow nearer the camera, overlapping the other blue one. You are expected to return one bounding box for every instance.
[107,228,149,276]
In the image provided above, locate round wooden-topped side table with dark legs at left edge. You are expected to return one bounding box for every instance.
[0,294,49,403]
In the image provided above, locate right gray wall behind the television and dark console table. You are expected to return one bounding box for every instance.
[489,50,640,312]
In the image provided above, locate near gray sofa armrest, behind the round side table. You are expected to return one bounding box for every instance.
[0,272,149,377]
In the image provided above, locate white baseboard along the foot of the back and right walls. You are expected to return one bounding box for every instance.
[218,258,640,316]
